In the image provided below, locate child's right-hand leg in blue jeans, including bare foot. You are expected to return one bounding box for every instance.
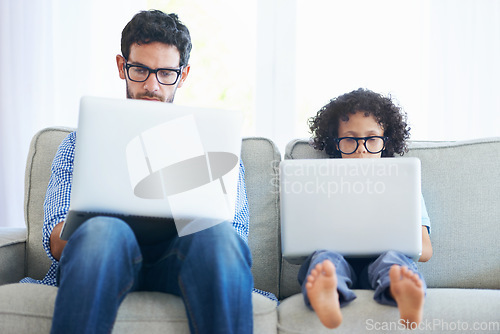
[368,251,427,326]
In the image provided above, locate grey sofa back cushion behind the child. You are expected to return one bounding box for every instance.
[280,138,500,298]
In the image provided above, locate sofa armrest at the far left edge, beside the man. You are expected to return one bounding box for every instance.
[0,227,26,285]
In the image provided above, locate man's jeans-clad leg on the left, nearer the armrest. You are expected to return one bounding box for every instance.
[52,217,142,333]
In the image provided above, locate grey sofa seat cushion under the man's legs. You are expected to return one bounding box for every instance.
[0,283,277,334]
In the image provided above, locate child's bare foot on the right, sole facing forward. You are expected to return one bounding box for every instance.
[389,265,424,329]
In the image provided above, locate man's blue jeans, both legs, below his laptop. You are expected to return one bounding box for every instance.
[52,217,253,333]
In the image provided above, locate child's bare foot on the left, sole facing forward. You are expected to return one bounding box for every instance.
[306,260,342,328]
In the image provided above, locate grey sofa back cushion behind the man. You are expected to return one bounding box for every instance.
[25,127,281,295]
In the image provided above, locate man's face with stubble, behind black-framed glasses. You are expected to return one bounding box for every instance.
[116,42,189,102]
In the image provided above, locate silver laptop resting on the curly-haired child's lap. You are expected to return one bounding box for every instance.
[280,158,422,263]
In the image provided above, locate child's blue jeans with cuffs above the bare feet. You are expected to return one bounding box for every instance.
[298,250,427,308]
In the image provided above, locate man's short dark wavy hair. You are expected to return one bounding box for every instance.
[121,10,192,66]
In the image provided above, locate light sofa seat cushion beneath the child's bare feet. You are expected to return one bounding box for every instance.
[278,289,500,334]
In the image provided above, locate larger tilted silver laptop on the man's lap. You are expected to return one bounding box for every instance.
[61,97,243,244]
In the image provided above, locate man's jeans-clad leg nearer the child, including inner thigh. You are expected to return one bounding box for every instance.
[141,222,253,334]
